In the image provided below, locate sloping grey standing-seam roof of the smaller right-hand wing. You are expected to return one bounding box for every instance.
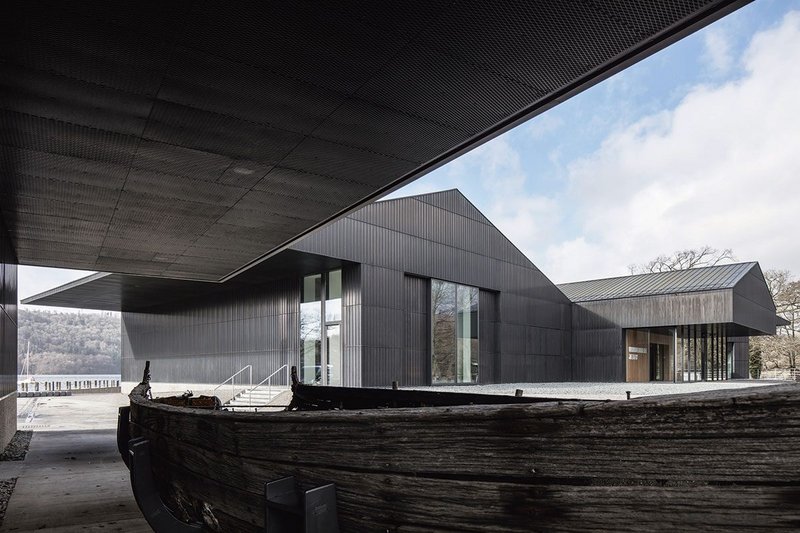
[558,262,758,302]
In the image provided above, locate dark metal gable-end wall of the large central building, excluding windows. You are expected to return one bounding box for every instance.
[293,190,572,386]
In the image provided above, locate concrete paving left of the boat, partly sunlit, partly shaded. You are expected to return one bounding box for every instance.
[0,394,152,533]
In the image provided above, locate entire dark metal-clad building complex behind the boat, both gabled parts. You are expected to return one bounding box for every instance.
[25,190,776,386]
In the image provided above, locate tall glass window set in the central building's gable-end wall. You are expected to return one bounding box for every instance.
[431,279,480,384]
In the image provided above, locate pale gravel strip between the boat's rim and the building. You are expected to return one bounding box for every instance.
[410,379,786,400]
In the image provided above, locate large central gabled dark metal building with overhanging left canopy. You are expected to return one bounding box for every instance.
[26,190,571,386]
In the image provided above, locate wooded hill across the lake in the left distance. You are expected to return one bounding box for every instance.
[17,309,120,375]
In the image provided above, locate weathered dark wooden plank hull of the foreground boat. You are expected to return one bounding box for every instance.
[130,384,800,532]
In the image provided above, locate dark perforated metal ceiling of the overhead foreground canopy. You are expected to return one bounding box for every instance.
[0,0,746,281]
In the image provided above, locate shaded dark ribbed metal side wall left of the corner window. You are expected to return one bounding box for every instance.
[122,280,300,383]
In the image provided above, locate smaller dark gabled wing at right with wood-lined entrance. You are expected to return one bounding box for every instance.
[559,263,778,381]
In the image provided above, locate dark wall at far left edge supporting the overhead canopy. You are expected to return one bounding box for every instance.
[0,217,17,448]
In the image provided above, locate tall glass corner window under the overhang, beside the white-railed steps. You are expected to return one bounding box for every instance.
[300,270,342,386]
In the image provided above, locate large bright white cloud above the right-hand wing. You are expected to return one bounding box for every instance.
[540,12,800,282]
